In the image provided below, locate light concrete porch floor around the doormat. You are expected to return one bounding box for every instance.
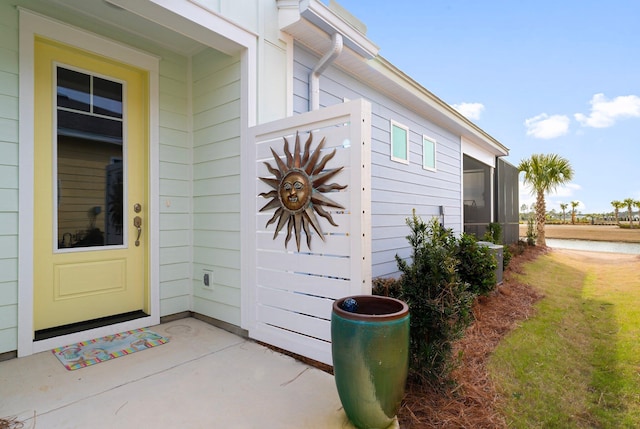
[0,318,370,429]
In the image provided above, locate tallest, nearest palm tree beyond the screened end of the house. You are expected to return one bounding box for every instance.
[518,154,573,246]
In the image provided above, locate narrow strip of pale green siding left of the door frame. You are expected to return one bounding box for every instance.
[0,2,19,353]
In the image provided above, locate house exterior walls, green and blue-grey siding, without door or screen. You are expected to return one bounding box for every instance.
[0,0,510,353]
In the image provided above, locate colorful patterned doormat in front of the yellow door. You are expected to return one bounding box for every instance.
[51,328,169,371]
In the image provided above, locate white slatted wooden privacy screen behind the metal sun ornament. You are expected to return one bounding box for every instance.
[242,100,371,364]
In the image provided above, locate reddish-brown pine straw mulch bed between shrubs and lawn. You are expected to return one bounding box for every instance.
[398,246,548,429]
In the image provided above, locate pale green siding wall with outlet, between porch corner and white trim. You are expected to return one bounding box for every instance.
[191,49,241,326]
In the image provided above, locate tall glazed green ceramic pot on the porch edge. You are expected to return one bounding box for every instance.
[331,295,409,429]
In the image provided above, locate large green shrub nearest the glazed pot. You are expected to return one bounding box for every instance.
[396,212,475,382]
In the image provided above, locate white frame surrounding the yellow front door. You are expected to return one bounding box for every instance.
[18,9,160,357]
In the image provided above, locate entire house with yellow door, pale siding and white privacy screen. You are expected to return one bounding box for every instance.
[0,0,518,362]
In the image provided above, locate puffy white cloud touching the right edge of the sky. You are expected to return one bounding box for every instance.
[573,94,640,128]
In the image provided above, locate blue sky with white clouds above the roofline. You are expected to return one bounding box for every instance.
[327,0,640,213]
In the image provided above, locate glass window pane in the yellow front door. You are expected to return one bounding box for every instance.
[56,66,125,249]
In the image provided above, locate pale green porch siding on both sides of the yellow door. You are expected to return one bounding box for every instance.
[0,0,248,353]
